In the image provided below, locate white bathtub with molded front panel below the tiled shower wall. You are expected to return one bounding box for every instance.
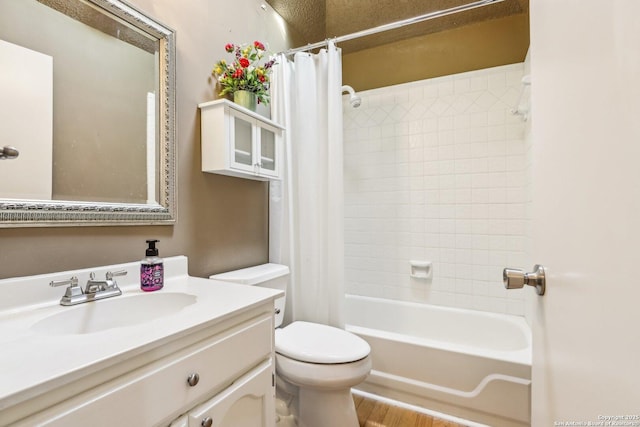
[346,295,531,427]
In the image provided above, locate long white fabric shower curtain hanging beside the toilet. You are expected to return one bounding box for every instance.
[269,42,344,327]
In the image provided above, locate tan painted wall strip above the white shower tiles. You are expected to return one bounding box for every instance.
[342,14,529,91]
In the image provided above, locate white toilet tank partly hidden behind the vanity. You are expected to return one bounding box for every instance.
[209,263,289,327]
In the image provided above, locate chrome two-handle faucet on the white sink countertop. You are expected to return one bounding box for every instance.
[49,270,127,306]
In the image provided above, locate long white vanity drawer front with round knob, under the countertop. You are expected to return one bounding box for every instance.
[18,314,273,427]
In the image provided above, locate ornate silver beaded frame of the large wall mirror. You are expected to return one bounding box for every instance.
[0,0,177,228]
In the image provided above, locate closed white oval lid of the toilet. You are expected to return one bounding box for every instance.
[275,321,371,364]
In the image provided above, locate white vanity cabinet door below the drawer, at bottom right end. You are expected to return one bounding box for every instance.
[189,359,276,427]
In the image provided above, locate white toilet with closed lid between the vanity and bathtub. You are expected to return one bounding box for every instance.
[209,263,371,427]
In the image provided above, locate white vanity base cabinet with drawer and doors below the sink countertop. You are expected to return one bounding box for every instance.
[8,301,275,427]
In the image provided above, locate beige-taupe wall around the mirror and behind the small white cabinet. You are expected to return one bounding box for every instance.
[0,0,297,280]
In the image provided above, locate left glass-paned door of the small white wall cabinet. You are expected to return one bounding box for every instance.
[229,109,259,177]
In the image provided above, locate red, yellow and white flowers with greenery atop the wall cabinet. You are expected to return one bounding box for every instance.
[211,41,275,104]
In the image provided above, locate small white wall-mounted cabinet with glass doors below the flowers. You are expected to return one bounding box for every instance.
[199,99,284,181]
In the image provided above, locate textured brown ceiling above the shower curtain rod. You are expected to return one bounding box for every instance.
[266,0,529,53]
